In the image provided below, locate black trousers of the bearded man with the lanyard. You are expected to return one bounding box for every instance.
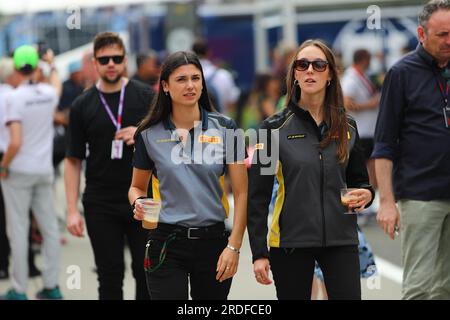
[83,202,150,300]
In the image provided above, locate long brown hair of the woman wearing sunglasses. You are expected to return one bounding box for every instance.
[286,39,348,162]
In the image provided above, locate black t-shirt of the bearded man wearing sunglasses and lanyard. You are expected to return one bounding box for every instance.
[66,80,154,203]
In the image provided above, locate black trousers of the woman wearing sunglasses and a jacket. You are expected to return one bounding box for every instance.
[270,245,361,300]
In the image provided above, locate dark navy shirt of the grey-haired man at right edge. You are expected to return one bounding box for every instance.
[372,44,450,201]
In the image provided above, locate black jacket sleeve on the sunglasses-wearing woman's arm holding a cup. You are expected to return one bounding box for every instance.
[346,119,375,208]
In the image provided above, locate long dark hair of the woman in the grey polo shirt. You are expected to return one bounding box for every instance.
[135,51,215,136]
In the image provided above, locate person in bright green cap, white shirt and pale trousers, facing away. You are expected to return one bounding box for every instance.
[0,46,62,300]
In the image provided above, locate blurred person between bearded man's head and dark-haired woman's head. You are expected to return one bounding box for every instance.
[131,50,161,92]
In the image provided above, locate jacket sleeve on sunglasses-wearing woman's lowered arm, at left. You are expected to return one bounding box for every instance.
[247,122,278,262]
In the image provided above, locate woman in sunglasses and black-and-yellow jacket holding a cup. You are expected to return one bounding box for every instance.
[248,40,373,299]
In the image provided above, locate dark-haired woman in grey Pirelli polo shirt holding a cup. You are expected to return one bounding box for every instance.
[129,52,247,300]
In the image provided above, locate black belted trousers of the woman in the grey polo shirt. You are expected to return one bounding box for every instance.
[146,224,231,300]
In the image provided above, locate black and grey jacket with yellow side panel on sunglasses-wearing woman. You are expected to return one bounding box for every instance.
[248,97,374,261]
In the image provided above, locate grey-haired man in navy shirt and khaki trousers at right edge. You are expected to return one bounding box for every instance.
[372,0,450,299]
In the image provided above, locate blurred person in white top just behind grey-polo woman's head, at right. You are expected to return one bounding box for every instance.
[192,39,240,114]
